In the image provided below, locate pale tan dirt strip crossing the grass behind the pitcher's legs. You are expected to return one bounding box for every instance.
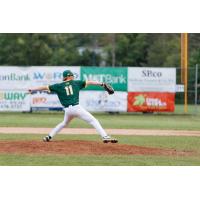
[0,127,200,136]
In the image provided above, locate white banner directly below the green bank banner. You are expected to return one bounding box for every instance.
[80,91,127,112]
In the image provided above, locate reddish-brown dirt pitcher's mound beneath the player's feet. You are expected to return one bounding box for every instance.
[0,140,192,155]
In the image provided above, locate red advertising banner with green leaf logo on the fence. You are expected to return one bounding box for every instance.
[128,92,175,112]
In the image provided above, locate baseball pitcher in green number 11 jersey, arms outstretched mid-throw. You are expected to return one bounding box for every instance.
[28,70,118,143]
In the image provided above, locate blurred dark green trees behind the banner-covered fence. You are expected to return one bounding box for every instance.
[0,33,200,67]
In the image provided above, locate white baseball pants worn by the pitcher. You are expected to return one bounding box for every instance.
[49,105,108,137]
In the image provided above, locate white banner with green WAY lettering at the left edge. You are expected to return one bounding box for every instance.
[0,90,30,111]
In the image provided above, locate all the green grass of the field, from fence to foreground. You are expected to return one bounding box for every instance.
[0,108,200,166]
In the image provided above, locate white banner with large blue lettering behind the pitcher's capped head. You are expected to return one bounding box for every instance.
[30,66,80,86]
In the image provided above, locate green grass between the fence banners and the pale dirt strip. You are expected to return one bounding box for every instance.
[0,112,200,130]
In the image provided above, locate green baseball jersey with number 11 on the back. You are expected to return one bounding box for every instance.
[49,80,86,107]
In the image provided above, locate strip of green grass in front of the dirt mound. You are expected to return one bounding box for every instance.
[0,154,200,166]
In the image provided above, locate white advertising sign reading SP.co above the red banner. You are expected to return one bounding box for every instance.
[128,67,176,93]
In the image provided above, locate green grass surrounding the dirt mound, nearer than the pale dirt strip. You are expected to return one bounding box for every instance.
[0,134,200,166]
